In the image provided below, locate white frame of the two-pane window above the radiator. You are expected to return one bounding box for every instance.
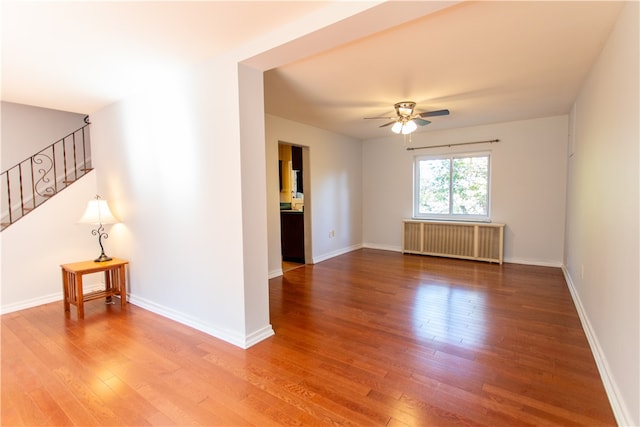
[413,151,491,222]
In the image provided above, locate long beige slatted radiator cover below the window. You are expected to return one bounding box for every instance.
[402,220,504,264]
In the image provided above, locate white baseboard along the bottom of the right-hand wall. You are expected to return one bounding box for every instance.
[562,265,634,426]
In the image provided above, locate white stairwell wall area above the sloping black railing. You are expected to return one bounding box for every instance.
[0,101,85,171]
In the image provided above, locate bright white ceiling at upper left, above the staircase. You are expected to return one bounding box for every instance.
[1,0,326,114]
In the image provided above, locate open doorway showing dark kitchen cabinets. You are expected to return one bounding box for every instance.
[278,142,310,272]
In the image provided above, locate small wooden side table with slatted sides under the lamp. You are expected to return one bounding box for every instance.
[60,258,129,319]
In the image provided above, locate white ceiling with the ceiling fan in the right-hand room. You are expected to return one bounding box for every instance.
[265,1,621,138]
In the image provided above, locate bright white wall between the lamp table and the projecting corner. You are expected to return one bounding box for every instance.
[92,58,260,347]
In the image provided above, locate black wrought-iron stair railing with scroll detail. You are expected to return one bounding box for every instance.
[0,123,92,231]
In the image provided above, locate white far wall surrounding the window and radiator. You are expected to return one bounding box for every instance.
[363,112,568,266]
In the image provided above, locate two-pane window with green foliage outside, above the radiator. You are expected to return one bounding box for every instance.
[413,152,491,221]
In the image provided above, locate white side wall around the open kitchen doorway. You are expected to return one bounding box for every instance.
[266,115,362,276]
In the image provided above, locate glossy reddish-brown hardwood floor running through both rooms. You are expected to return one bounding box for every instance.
[1,249,615,426]
